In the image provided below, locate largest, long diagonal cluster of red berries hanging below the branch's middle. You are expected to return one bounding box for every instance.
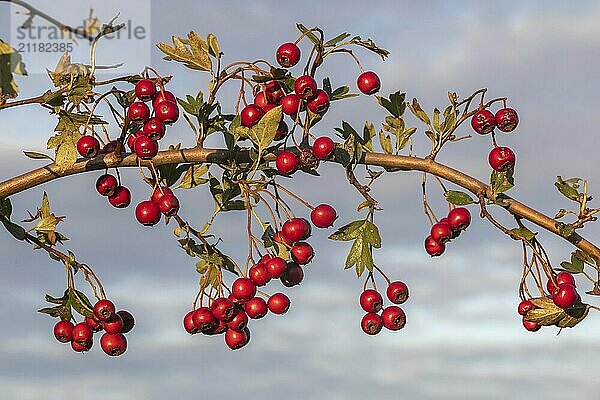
[183,204,337,350]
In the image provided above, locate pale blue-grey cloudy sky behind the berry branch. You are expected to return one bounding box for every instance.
[0,0,600,400]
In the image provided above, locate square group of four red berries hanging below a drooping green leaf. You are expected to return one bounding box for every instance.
[360,281,408,335]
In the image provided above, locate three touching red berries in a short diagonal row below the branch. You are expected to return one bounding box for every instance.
[425,207,471,257]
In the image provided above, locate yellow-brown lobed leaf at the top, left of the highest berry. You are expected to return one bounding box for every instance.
[156,31,212,71]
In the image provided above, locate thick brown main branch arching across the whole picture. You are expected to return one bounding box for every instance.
[0,147,600,262]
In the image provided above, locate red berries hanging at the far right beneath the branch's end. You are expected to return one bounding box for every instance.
[517,271,581,332]
